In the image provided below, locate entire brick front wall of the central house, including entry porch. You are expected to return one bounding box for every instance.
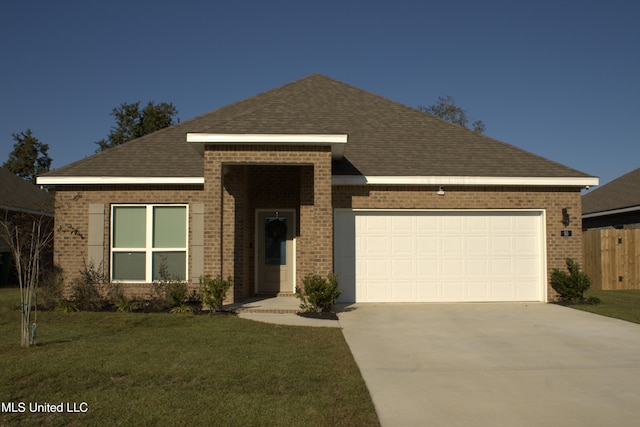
[54,167,582,302]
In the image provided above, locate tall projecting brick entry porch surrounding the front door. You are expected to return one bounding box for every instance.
[204,145,333,300]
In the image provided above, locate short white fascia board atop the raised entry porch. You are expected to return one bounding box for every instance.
[187,133,349,159]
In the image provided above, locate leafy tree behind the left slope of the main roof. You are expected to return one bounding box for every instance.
[96,101,178,152]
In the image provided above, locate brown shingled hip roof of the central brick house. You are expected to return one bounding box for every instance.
[39,74,597,185]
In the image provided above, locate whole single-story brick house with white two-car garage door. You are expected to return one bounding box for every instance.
[38,75,598,302]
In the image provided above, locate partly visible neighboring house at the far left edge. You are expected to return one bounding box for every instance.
[0,167,53,285]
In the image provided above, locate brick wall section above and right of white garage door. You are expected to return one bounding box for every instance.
[333,186,582,301]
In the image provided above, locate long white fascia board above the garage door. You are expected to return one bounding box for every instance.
[331,175,599,187]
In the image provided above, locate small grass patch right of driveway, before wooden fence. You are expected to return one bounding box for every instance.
[569,289,640,323]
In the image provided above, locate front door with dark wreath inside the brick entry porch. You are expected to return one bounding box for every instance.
[256,210,296,294]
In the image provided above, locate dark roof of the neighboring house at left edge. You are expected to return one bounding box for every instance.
[0,167,53,214]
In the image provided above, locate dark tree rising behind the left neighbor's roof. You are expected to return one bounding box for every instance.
[3,129,52,184]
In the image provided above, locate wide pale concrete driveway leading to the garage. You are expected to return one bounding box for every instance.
[339,303,640,427]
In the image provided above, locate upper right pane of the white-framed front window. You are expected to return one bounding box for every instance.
[153,206,187,248]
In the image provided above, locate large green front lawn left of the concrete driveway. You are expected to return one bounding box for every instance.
[0,289,379,426]
